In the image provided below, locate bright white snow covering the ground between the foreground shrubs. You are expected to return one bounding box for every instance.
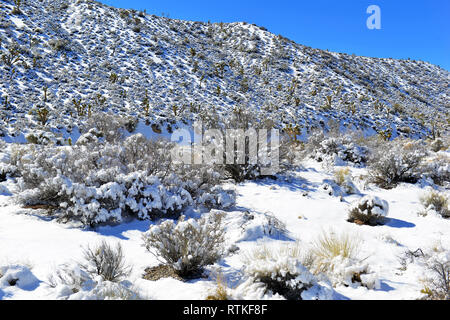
[0,160,450,299]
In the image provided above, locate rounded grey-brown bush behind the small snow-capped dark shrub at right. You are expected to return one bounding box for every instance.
[369,139,427,189]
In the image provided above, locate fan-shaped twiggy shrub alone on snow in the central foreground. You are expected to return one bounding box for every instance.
[143,213,224,277]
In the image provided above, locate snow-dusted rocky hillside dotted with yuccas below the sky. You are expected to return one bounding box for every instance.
[0,0,450,141]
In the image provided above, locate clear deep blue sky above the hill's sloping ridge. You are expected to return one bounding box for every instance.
[101,0,450,70]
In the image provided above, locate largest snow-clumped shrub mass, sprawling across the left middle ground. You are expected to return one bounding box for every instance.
[11,129,235,226]
